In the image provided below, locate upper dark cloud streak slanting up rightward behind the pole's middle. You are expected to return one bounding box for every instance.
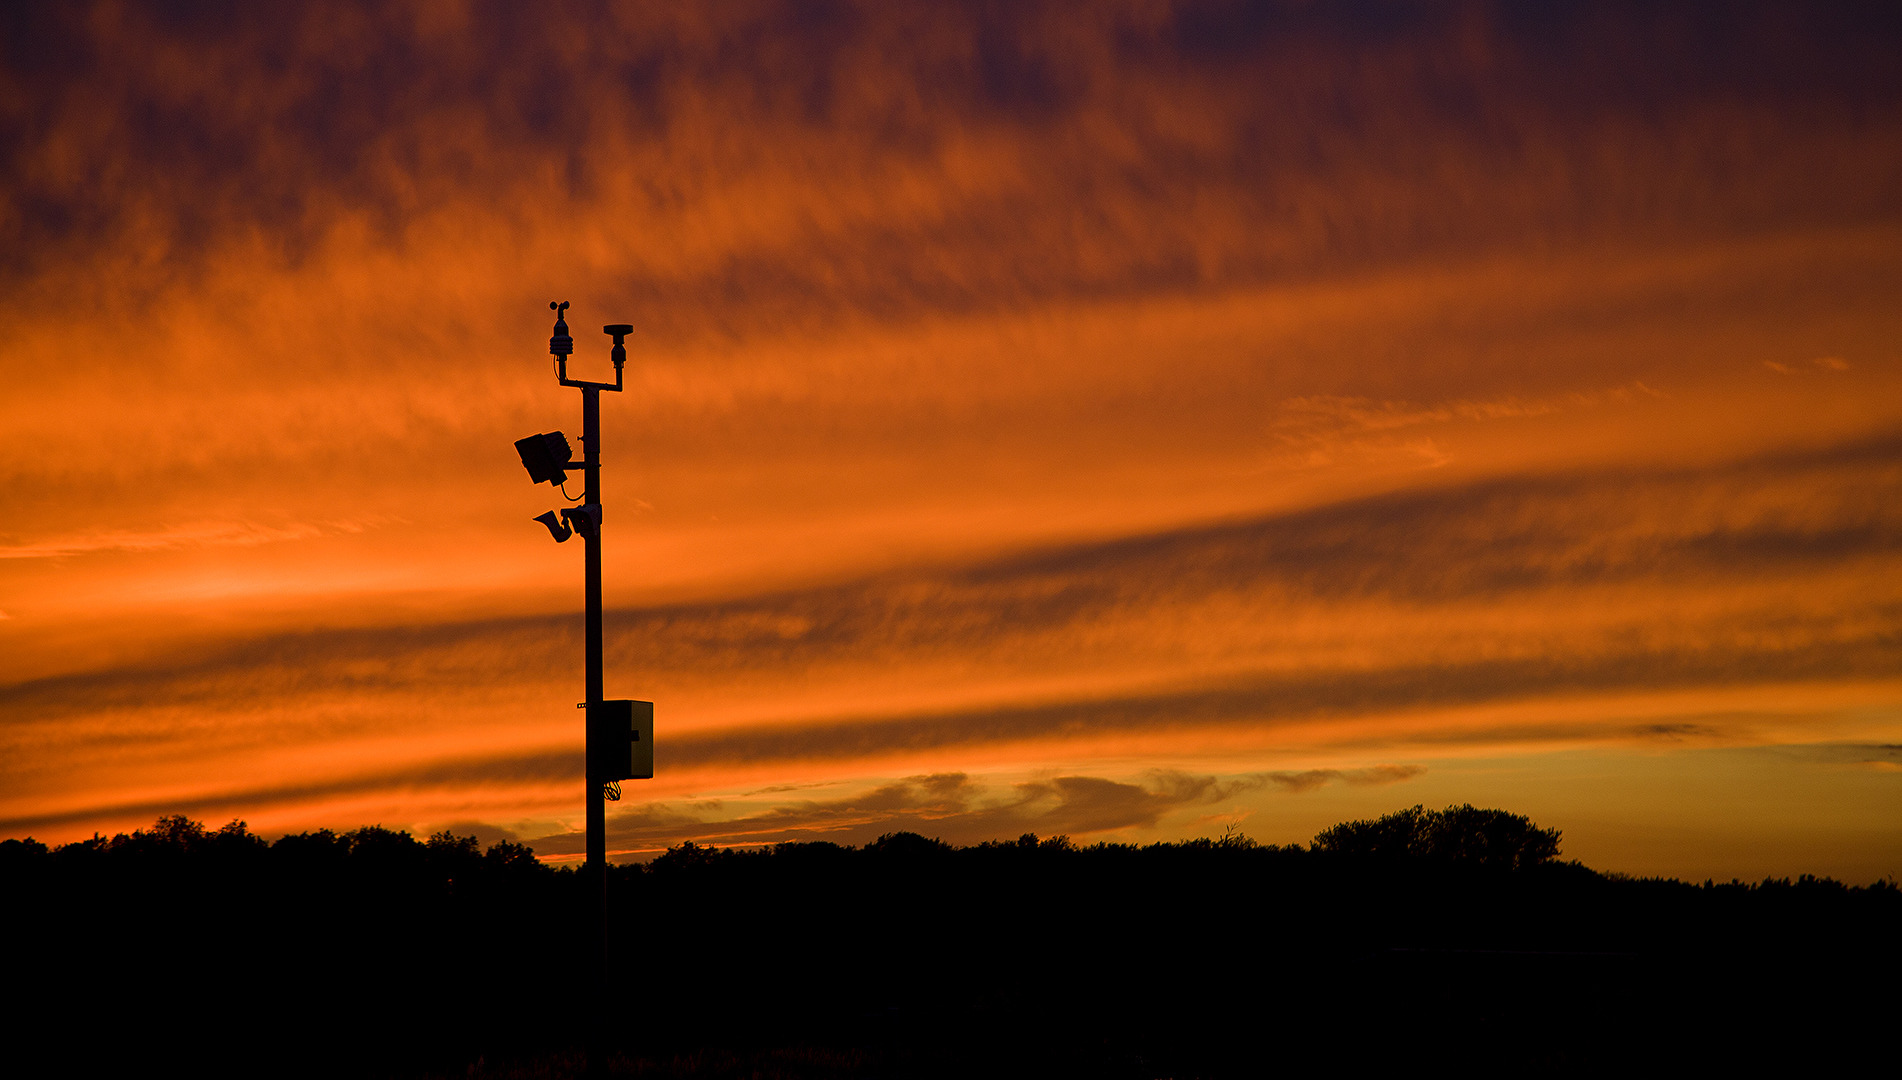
[0,425,1902,709]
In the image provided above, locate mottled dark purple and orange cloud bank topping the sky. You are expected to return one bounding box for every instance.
[0,4,1902,338]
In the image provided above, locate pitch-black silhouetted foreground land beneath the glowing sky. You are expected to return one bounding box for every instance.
[0,820,1902,1078]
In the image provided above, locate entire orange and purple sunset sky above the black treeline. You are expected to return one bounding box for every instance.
[0,2,1902,882]
